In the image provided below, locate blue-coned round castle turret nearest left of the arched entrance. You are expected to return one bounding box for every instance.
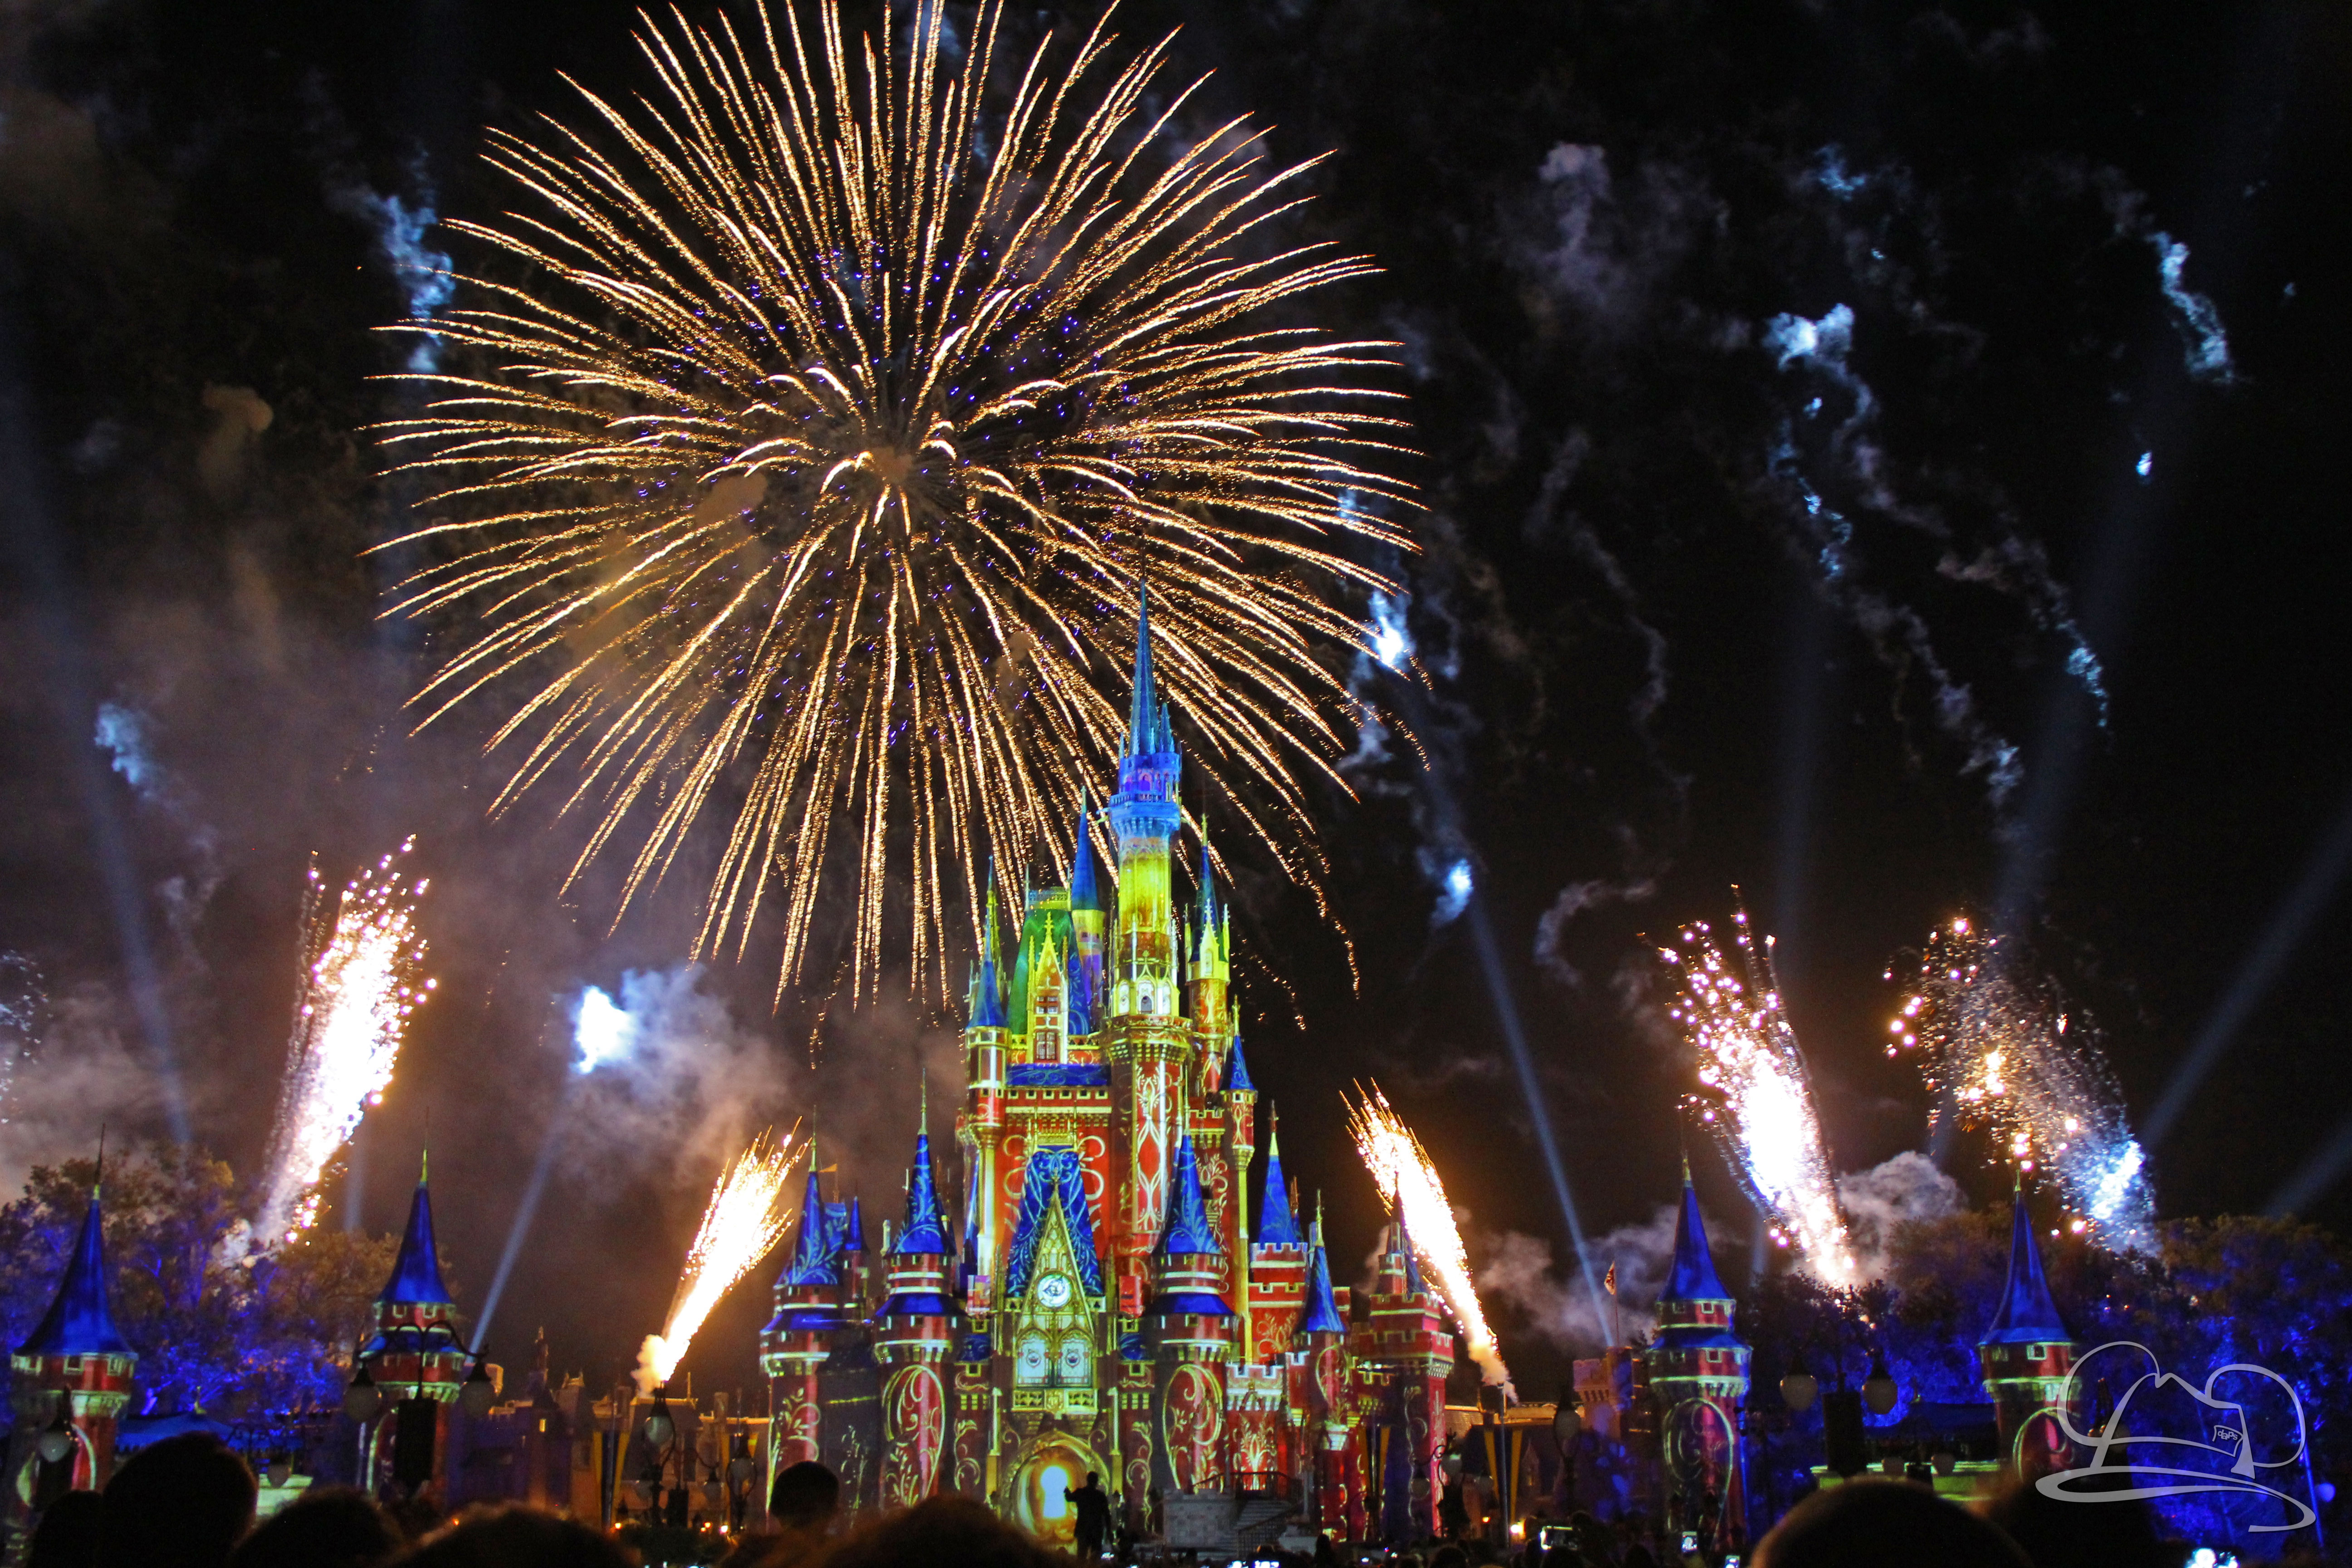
[875,1107,960,1507]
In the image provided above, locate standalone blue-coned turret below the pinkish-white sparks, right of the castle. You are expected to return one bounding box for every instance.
[1649,1161,1748,1549]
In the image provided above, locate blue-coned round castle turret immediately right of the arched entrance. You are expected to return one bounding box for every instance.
[1143,1136,1232,1495]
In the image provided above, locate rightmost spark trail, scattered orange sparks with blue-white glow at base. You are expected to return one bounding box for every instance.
[1886,917,2157,1253]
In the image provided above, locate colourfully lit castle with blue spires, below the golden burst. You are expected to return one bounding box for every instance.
[760,607,1454,1542]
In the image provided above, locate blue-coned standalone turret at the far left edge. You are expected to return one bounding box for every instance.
[7,1182,139,1533]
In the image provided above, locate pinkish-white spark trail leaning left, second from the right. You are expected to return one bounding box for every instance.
[1658,910,1856,1286]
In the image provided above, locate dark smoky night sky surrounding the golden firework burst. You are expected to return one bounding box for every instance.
[0,0,2352,1394]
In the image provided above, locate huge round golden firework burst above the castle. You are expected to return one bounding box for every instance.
[386,0,1411,995]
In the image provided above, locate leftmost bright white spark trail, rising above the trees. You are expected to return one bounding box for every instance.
[254,839,433,1251]
